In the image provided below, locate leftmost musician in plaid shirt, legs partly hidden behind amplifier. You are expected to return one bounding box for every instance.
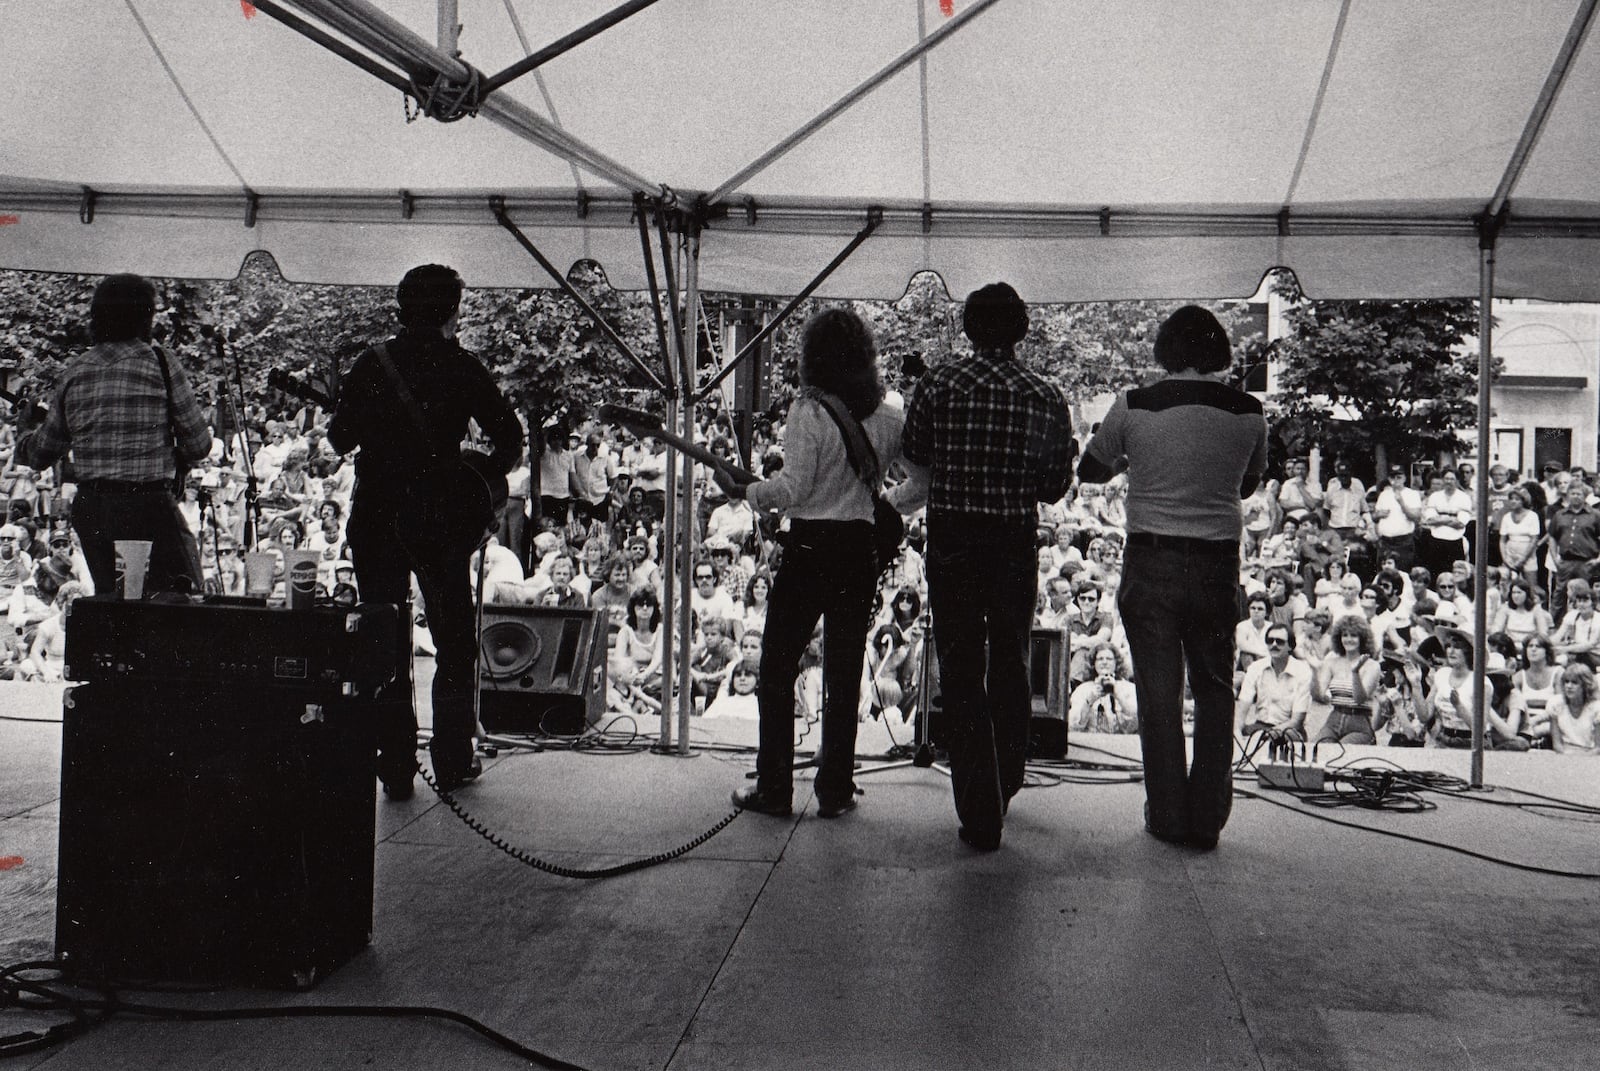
[16,275,211,594]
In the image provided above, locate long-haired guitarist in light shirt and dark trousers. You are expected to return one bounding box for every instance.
[713,309,902,818]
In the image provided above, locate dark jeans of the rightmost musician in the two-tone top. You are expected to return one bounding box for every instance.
[1117,543,1238,839]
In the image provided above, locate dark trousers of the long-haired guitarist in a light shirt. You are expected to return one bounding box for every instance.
[755,520,878,802]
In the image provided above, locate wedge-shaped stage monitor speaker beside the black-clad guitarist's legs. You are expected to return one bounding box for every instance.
[478,604,606,736]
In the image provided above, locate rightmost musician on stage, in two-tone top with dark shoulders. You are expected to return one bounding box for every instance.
[1078,306,1267,850]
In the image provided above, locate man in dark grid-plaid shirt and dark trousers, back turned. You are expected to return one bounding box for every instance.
[890,283,1078,852]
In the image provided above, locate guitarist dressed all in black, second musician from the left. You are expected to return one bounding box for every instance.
[328,264,523,799]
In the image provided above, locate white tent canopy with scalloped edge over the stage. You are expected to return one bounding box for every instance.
[0,0,1600,301]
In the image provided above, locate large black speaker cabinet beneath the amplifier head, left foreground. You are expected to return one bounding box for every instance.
[56,680,376,988]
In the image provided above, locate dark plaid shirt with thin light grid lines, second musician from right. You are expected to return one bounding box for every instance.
[904,351,1078,522]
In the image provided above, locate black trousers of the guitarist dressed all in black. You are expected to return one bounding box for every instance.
[346,499,478,783]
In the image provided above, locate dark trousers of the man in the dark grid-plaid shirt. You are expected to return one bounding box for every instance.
[928,514,1036,839]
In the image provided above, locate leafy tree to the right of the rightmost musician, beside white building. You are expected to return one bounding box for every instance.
[1270,275,1478,467]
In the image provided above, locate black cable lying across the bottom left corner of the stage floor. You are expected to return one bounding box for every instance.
[0,961,584,1071]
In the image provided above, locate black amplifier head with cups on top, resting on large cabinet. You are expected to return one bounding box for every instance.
[62,596,400,695]
